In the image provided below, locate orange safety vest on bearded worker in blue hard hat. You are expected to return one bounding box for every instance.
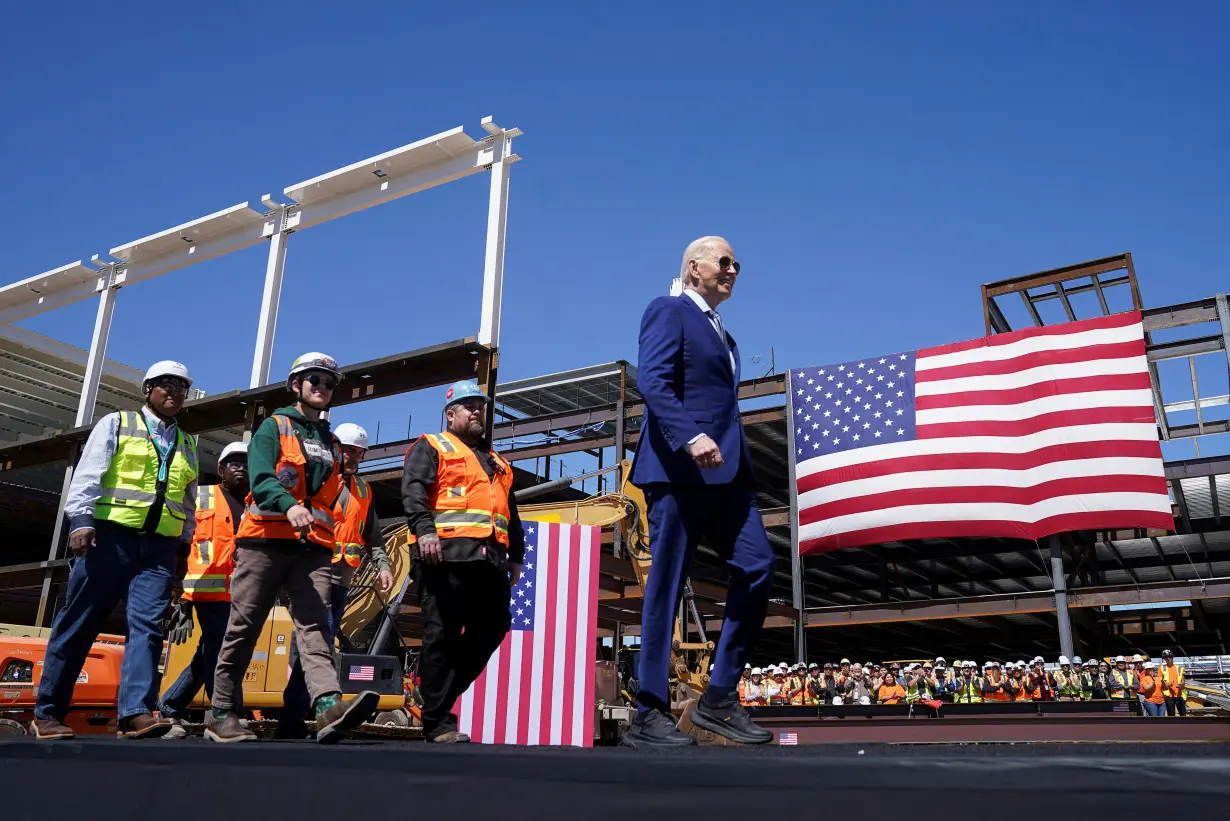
[410,431,513,548]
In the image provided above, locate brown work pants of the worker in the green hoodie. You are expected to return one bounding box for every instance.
[213,542,342,710]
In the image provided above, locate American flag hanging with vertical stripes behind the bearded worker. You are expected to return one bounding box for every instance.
[458,522,600,747]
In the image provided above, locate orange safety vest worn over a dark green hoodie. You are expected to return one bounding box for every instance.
[235,414,343,551]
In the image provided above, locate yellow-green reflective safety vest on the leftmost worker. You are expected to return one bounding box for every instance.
[93,411,199,538]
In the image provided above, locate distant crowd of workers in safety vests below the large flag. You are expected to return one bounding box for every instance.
[739,650,1187,716]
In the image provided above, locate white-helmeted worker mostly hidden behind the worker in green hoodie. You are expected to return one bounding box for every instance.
[274,422,392,739]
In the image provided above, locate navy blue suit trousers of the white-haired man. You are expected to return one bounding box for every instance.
[637,483,775,711]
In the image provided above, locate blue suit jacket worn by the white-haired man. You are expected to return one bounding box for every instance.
[632,295,752,486]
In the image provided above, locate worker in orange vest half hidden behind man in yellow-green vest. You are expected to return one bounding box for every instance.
[157,442,248,739]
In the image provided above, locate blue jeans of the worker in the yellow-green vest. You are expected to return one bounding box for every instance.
[34,522,177,721]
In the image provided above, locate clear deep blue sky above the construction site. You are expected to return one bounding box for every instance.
[0,0,1230,468]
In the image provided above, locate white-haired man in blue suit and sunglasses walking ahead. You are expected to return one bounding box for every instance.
[624,236,774,747]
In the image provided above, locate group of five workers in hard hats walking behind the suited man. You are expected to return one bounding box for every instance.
[31,352,524,743]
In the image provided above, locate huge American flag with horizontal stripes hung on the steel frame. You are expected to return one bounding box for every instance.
[788,311,1175,554]
